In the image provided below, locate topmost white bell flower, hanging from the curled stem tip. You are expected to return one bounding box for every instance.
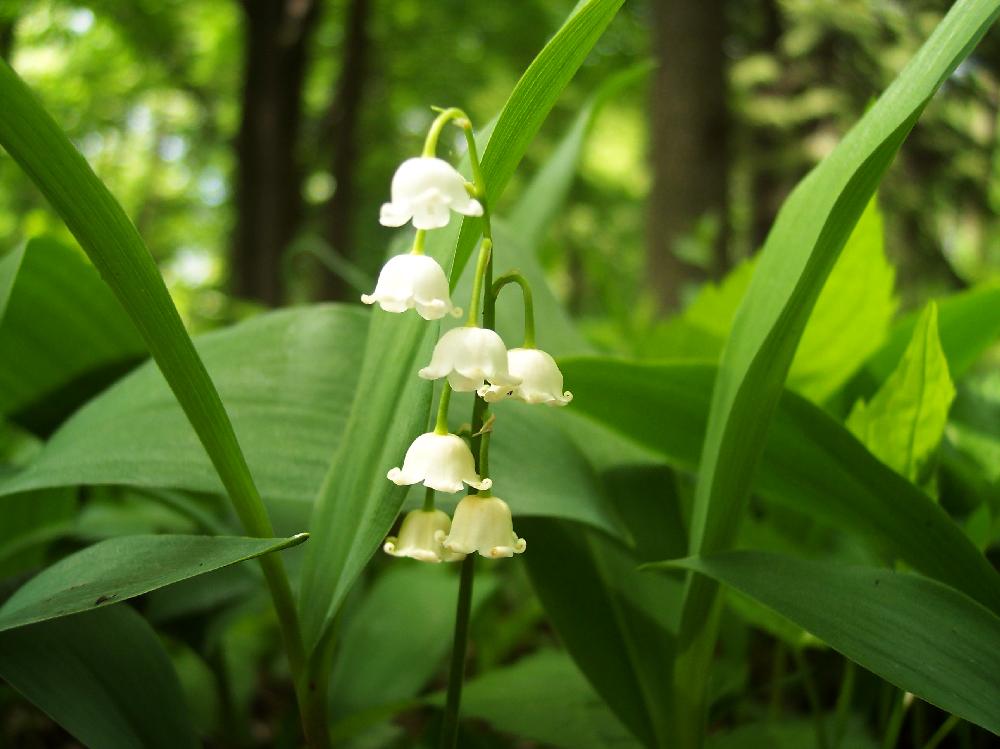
[379,156,483,229]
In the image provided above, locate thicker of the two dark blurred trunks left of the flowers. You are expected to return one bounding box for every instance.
[232,0,318,305]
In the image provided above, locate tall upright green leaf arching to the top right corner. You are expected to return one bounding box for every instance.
[674,0,1000,736]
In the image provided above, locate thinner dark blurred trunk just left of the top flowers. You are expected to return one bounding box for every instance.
[320,0,372,299]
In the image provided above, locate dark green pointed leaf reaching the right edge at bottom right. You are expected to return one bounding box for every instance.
[667,551,1000,734]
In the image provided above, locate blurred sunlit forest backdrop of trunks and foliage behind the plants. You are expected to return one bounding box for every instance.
[0,0,1000,340]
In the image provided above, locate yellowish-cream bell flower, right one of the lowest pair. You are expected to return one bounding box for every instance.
[437,494,528,559]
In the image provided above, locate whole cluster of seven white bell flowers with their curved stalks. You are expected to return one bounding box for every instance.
[361,109,573,562]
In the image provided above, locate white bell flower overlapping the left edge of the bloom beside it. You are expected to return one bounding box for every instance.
[419,326,521,393]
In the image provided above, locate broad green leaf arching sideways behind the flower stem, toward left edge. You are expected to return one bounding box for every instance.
[0,305,621,536]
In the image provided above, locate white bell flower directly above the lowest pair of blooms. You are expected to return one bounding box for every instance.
[386,432,493,493]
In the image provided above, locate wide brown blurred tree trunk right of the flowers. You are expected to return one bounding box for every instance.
[647,0,728,309]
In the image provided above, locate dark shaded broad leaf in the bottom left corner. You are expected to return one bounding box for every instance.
[0,606,199,749]
